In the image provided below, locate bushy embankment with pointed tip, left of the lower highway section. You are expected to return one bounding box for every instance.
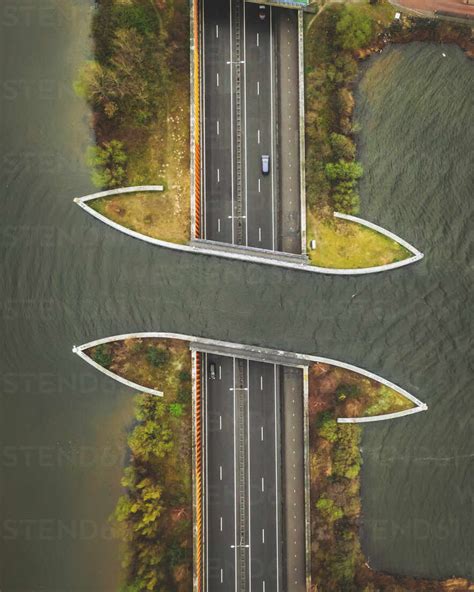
[86,339,193,592]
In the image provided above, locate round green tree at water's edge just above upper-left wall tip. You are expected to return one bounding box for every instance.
[87,140,128,189]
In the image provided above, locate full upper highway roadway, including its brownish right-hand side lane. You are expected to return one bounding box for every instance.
[201,0,301,253]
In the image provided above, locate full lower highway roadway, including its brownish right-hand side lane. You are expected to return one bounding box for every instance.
[202,353,305,592]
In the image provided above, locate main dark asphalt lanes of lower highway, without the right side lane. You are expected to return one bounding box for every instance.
[203,354,282,592]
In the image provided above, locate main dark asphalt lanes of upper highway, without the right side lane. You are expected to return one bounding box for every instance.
[201,0,286,250]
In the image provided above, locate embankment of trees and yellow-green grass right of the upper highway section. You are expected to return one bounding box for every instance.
[305,1,474,268]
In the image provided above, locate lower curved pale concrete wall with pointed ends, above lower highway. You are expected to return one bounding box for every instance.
[73,332,428,423]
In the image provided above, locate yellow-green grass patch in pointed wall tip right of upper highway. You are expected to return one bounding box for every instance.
[307,214,411,269]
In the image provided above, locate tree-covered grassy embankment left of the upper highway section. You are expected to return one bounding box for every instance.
[76,0,190,243]
